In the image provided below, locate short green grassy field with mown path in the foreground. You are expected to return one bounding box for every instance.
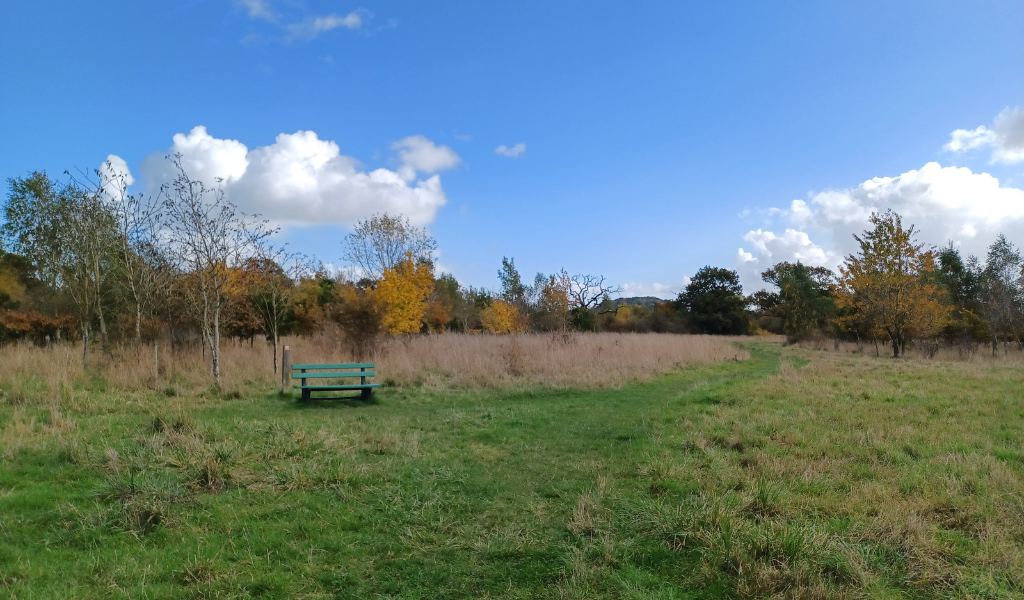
[0,344,1024,599]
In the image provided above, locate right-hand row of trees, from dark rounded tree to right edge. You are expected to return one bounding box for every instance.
[704,211,1024,356]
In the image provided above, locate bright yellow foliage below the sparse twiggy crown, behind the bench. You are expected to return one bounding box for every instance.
[373,254,434,334]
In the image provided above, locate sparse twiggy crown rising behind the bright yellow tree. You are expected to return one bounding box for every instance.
[343,213,437,280]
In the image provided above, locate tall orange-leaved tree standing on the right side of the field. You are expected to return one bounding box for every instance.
[839,211,948,358]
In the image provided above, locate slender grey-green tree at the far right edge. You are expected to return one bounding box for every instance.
[982,233,1024,355]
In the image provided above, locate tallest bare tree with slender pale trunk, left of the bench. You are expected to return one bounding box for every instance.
[161,154,275,385]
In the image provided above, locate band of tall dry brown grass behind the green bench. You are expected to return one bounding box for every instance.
[0,333,746,392]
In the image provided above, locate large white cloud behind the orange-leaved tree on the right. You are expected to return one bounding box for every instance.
[736,158,1024,289]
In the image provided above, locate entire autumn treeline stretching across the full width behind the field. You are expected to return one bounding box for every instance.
[0,157,1024,382]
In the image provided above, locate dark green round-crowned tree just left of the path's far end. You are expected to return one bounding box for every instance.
[676,266,750,335]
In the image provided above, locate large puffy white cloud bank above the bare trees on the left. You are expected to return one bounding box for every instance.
[137,126,460,225]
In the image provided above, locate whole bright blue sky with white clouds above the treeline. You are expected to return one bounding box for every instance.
[0,0,1024,295]
